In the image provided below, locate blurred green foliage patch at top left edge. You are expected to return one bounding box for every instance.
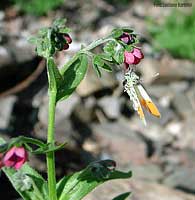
[13,0,64,16]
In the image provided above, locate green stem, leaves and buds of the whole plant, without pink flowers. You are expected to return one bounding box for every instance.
[0,19,137,200]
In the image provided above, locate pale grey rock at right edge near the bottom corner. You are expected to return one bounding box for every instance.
[163,167,195,193]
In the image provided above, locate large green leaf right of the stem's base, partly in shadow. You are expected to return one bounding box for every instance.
[57,161,132,200]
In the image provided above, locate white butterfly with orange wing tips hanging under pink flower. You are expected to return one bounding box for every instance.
[123,70,160,125]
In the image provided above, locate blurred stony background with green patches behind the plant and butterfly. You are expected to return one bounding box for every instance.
[0,0,195,200]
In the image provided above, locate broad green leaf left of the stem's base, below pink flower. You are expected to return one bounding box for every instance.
[0,138,49,200]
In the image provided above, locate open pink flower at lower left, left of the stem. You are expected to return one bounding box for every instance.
[3,146,28,170]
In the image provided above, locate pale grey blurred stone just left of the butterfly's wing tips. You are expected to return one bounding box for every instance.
[98,96,120,119]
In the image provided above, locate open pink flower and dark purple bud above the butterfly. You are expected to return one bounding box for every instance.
[119,32,144,69]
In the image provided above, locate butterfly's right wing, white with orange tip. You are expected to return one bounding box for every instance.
[134,84,160,117]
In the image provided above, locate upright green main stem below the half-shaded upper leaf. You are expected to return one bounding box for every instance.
[46,91,57,200]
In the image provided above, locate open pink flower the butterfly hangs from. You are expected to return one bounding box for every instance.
[124,48,144,67]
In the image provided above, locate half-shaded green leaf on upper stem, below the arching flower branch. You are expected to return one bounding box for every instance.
[57,54,88,101]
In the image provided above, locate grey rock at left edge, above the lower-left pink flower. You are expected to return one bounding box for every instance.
[0,96,16,129]
